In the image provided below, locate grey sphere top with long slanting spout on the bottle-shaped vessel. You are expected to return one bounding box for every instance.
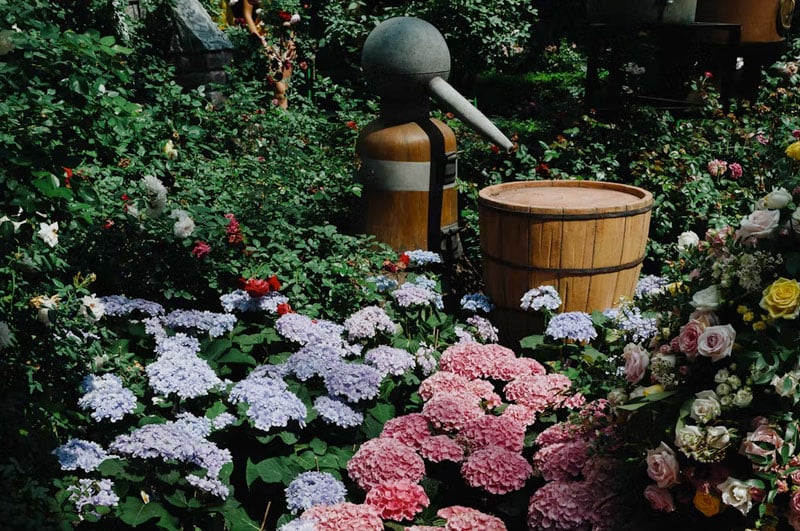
[361,17,514,152]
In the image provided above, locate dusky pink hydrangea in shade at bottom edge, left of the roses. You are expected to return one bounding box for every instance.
[528,481,593,531]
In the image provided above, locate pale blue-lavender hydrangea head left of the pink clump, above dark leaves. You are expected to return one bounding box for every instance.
[228,374,308,431]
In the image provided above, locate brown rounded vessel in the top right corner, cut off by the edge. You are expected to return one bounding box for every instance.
[696,0,795,43]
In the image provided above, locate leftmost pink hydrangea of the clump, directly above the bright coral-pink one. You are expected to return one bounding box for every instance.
[347,438,425,491]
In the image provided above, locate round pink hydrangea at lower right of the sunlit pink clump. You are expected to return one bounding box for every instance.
[461,446,533,494]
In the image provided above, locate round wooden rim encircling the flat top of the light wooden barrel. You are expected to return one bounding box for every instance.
[478,181,653,220]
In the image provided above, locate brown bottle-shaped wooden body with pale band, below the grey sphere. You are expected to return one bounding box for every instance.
[356,118,458,252]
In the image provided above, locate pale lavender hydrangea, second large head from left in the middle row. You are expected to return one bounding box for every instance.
[145,333,222,399]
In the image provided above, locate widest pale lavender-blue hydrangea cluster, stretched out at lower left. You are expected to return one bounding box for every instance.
[109,421,232,478]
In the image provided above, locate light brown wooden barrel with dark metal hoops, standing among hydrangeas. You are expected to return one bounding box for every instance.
[478,181,653,342]
